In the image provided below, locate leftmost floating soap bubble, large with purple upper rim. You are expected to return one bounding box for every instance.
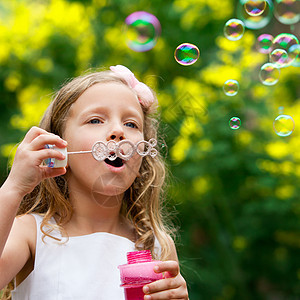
[125,11,161,52]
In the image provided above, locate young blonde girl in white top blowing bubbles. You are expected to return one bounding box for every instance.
[0,65,188,300]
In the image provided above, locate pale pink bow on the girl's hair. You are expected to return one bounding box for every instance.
[110,65,155,108]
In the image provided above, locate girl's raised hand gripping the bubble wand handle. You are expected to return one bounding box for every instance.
[7,127,67,197]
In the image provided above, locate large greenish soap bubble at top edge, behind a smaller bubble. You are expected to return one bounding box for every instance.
[237,0,273,29]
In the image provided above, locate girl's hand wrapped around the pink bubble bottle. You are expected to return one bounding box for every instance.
[143,260,189,300]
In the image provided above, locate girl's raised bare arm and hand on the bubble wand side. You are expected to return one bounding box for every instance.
[0,127,66,289]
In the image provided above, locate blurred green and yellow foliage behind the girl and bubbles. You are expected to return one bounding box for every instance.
[0,0,300,300]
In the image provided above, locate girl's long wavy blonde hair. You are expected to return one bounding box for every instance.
[2,71,174,299]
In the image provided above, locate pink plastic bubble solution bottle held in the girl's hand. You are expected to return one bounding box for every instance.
[119,250,163,300]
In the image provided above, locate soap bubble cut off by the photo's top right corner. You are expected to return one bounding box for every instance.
[274,0,300,25]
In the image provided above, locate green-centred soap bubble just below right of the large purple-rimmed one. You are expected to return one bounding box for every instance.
[174,43,200,66]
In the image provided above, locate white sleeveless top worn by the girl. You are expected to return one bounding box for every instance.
[12,214,161,300]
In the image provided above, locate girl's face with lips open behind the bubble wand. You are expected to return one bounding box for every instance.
[63,82,144,196]
